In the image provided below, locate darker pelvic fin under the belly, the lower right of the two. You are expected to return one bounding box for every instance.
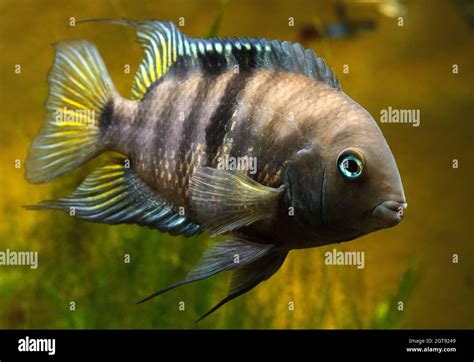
[197,249,288,322]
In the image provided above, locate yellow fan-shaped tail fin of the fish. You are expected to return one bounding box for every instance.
[26,41,117,183]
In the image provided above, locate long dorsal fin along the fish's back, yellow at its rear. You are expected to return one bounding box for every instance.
[119,20,340,100]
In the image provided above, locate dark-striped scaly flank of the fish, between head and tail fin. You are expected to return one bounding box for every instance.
[104,70,362,244]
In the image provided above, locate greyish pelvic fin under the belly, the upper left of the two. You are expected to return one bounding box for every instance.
[139,240,273,303]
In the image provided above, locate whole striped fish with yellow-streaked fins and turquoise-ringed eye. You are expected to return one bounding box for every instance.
[25,19,407,320]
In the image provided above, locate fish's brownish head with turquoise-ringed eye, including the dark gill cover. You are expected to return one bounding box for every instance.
[286,91,407,242]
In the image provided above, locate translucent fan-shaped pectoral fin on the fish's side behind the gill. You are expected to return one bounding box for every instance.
[189,167,284,235]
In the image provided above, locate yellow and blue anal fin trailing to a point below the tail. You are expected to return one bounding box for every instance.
[27,159,201,236]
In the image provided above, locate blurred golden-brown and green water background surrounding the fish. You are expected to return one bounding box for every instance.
[0,0,474,328]
